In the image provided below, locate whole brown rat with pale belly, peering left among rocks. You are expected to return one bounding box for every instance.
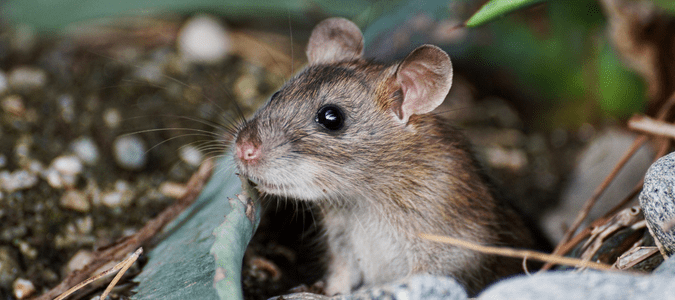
[233,18,533,295]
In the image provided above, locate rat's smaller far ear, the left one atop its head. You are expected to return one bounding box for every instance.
[307,18,363,65]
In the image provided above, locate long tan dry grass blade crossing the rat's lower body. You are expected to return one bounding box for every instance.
[420,234,617,271]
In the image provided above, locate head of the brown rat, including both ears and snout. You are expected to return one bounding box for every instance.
[234,18,452,200]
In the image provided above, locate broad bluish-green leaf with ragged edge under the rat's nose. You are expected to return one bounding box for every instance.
[132,156,258,300]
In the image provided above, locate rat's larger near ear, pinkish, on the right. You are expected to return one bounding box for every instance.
[394,45,452,123]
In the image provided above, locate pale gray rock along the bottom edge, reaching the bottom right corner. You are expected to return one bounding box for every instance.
[478,271,675,300]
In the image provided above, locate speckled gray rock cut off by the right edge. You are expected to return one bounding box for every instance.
[640,152,675,257]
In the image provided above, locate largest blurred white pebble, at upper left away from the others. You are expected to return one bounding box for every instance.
[177,15,232,63]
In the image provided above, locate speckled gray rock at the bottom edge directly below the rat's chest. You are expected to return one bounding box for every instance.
[272,275,468,300]
